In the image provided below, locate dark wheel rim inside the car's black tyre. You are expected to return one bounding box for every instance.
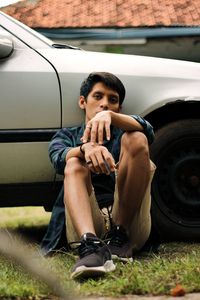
[152,137,200,226]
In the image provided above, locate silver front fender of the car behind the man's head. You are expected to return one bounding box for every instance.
[39,49,200,126]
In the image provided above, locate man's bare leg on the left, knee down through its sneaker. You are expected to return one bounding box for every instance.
[64,158,115,278]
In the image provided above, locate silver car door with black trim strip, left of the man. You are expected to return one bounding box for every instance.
[0,26,61,206]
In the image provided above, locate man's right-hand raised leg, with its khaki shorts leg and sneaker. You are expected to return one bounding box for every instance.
[109,132,155,260]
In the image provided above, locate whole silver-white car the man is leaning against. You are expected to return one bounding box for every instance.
[0,12,200,240]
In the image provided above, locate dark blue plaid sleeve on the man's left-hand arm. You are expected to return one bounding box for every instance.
[49,128,74,175]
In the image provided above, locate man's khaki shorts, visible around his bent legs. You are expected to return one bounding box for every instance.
[66,161,156,252]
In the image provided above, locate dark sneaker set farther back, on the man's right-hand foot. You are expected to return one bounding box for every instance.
[106,225,133,262]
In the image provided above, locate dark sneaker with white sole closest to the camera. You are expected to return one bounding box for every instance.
[71,233,115,279]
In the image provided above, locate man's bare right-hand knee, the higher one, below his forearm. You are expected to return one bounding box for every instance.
[121,131,149,156]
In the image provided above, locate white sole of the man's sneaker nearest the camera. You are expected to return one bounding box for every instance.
[71,260,116,279]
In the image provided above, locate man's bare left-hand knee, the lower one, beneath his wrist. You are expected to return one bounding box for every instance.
[64,157,87,177]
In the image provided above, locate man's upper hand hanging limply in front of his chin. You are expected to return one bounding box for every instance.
[82,111,111,145]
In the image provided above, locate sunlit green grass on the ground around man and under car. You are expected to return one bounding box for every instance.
[0,208,200,298]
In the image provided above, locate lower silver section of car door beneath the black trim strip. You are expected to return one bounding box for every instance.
[0,142,55,184]
